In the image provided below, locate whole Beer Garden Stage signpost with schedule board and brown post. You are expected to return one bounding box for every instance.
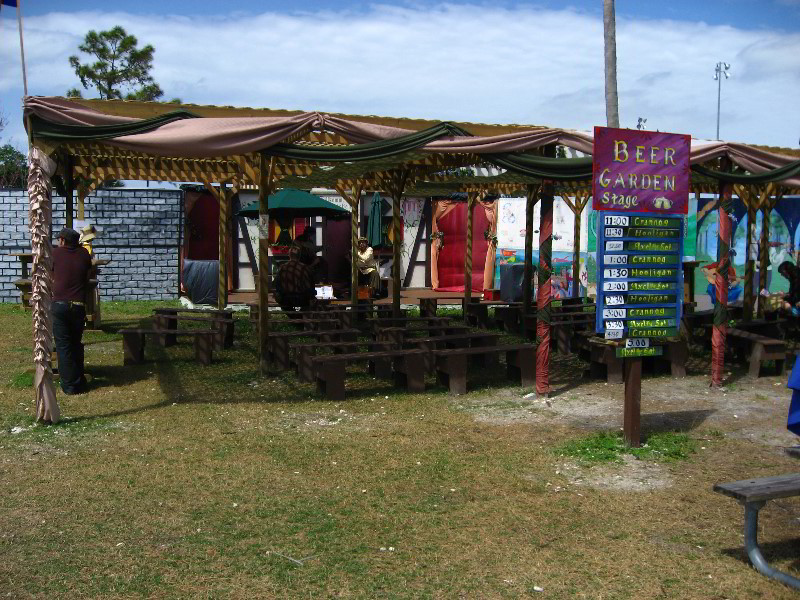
[592,127,691,446]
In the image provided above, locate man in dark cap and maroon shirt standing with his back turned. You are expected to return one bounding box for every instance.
[53,227,92,394]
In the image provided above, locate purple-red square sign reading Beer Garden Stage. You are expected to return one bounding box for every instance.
[592,127,691,214]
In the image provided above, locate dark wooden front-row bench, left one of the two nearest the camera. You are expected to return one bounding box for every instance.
[312,349,425,401]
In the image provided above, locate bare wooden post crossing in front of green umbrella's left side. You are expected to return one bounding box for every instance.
[258,153,275,375]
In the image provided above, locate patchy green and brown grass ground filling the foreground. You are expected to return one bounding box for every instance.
[0,303,800,599]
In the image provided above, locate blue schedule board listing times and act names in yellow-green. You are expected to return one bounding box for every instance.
[595,211,683,340]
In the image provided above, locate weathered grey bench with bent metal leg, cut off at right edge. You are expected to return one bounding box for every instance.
[714,473,800,589]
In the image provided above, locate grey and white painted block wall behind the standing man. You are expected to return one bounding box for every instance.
[0,188,183,302]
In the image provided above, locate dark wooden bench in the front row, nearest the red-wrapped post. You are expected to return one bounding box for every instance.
[433,344,536,394]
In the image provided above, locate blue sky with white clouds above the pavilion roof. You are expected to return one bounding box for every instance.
[0,0,800,148]
